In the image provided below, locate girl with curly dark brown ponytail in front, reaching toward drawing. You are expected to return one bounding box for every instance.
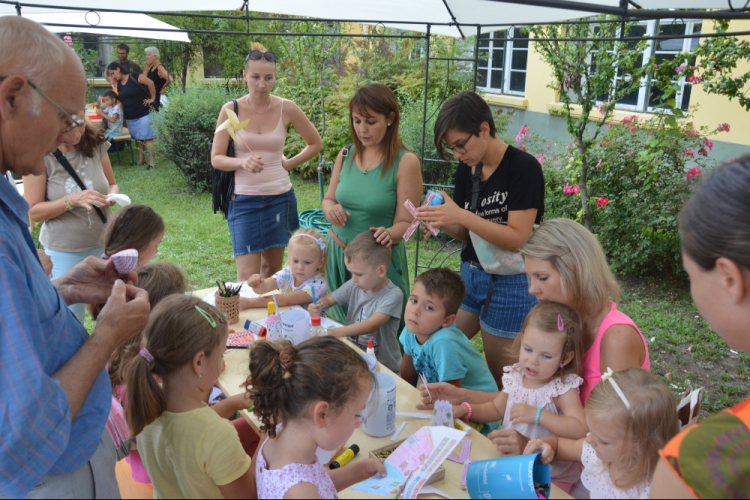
[248,337,385,498]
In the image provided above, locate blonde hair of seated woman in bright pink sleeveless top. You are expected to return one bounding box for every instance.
[521,219,620,324]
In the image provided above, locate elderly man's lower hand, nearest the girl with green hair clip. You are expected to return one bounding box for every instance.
[92,280,151,350]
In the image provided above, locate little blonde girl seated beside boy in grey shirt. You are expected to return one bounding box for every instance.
[240,229,328,309]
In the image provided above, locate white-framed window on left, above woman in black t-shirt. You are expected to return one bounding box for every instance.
[477,28,529,95]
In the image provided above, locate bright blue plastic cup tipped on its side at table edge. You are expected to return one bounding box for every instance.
[466,453,552,499]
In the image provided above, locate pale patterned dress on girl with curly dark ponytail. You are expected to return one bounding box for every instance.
[255,438,339,499]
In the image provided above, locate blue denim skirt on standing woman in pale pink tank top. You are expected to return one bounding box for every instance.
[227,189,299,257]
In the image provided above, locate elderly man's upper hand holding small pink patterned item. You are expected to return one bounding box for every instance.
[53,257,138,305]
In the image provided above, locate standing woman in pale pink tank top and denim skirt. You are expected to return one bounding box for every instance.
[211,43,323,281]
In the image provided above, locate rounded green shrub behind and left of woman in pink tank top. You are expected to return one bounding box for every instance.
[151,85,244,192]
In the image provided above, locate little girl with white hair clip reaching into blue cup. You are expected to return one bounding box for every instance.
[525,368,679,498]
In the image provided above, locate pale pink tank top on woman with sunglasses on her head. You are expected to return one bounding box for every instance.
[234,99,292,196]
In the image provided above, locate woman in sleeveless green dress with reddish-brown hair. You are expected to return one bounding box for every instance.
[322,83,422,325]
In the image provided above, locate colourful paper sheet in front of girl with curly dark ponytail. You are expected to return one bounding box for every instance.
[352,427,466,498]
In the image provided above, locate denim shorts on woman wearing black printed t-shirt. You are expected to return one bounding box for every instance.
[461,262,537,339]
